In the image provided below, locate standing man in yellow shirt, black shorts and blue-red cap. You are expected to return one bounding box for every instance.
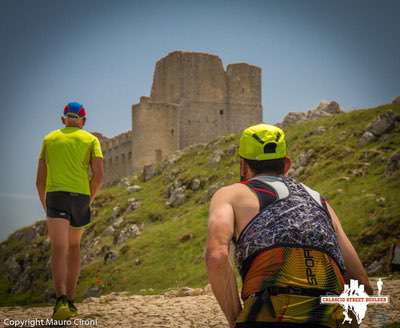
[36,102,103,320]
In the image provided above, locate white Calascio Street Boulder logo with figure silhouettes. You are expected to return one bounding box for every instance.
[321,278,389,324]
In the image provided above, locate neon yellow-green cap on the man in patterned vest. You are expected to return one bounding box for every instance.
[239,123,286,161]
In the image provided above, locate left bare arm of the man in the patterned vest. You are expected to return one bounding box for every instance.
[206,188,242,327]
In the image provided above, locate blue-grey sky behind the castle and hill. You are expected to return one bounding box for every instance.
[0,0,400,239]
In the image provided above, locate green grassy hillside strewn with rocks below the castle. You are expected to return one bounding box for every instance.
[0,104,400,305]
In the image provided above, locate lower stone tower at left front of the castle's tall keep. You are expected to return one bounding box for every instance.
[132,97,179,170]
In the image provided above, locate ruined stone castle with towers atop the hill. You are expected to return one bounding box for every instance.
[97,51,262,184]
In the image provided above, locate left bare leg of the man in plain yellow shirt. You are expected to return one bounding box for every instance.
[47,218,70,297]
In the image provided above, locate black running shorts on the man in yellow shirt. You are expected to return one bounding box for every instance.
[46,191,90,228]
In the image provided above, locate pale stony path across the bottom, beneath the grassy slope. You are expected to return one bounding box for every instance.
[0,280,400,328]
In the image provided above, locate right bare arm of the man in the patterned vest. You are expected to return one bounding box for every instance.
[326,202,373,295]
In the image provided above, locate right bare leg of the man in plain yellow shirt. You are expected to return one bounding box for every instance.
[66,227,84,300]
